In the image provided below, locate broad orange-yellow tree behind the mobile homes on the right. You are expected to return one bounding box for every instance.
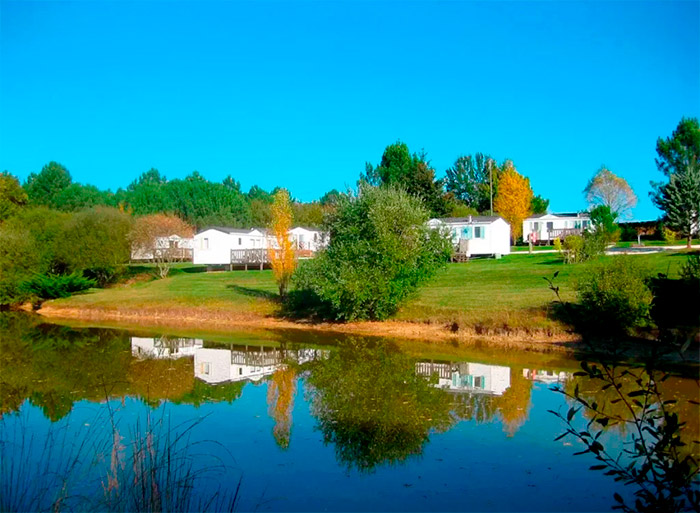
[493,160,532,242]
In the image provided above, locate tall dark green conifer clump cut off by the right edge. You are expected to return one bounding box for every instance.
[651,118,700,247]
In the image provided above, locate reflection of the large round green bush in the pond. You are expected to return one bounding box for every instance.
[309,341,451,470]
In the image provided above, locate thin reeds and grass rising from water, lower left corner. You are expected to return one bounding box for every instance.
[0,401,241,512]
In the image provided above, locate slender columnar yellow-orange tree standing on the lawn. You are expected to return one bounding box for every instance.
[268,189,297,299]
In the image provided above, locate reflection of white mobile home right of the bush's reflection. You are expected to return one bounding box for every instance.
[416,362,510,395]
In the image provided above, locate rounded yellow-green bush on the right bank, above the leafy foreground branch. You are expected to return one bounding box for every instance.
[576,256,652,333]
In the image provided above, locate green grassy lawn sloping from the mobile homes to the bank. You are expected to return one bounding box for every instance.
[52,253,686,329]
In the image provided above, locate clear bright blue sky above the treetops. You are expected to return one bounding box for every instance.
[0,0,700,219]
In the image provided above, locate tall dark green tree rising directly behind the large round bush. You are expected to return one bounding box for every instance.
[360,141,448,217]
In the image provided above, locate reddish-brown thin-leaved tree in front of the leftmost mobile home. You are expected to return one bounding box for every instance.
[131,214,194,278]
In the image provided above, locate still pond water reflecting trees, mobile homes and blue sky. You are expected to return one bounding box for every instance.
[0,316,699,511]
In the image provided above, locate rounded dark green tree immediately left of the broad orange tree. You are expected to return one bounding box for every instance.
[445,153,500,212]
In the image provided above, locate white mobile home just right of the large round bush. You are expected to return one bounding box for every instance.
[428,216,510,257]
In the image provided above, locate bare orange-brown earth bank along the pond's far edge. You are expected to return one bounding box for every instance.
[35,304,581,354]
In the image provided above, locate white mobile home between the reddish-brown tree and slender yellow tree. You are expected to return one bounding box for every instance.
[192,226,267,265]
